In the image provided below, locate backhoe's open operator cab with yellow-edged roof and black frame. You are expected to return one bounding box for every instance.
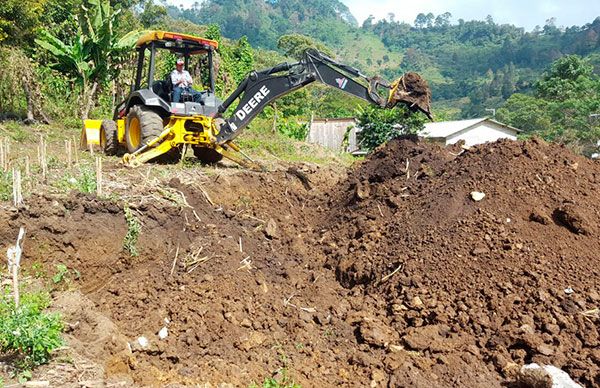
[115,31,222,119]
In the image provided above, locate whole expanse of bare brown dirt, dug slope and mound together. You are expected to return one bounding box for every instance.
[0,138,600,387]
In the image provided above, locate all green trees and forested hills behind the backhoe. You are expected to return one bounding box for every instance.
[0,0,600,153]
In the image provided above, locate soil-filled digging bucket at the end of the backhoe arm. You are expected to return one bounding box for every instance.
[387,73,433,120]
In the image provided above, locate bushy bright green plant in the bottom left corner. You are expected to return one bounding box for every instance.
[0,289,63,370]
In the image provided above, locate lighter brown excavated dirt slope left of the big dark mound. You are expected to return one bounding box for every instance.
[0,167,394,386]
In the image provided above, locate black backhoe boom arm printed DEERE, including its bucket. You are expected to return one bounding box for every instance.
[217,49,431,144]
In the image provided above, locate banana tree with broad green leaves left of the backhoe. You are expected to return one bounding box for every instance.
[35,0,143,119]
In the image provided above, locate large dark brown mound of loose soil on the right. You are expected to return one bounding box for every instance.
[323,138,600,386]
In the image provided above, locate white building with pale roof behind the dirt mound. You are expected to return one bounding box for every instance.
[419,118,521,146]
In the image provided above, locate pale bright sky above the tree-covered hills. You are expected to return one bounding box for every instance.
[167,0,600,31]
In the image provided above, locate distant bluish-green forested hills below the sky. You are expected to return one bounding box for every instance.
[169,0,600,117]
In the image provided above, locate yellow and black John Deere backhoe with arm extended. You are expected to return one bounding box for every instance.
[82,31,431,168]
